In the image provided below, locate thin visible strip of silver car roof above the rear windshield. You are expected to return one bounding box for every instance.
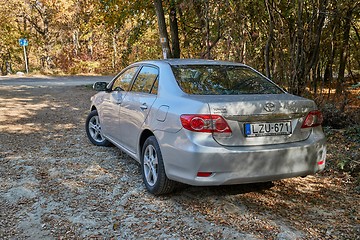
[138,58,246,66]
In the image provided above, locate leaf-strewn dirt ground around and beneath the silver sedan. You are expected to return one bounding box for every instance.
[0,86,360,239]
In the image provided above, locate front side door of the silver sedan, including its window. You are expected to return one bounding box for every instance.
[100,66,139,142]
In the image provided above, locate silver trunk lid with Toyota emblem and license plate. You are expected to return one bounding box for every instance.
[208,94,316,146]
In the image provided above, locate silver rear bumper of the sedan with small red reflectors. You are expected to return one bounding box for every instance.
[159,130,326,186]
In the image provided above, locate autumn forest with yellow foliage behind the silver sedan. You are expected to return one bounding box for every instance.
[0,0,360,99]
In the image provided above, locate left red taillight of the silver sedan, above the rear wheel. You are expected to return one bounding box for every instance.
[180,114,232,133]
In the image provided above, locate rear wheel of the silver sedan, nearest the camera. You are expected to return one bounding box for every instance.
[141,136,177,195]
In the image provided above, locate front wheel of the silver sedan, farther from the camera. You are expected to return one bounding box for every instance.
[85,110,110,147]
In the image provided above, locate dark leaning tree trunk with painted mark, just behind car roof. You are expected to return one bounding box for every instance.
[154,0,172,59]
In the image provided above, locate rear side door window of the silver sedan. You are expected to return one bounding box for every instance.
[131,66,159,94]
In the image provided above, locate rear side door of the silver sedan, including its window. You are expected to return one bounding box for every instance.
[120,66,159,153]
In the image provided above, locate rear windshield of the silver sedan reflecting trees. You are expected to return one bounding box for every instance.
[172,65,283,95]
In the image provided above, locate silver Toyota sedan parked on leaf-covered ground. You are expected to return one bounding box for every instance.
[86,59,326,195]
